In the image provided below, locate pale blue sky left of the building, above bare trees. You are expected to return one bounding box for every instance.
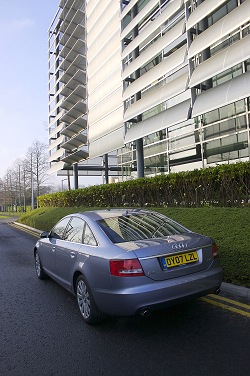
[0,0,59,178]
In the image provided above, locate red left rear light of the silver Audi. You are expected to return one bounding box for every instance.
[110,259,144,277]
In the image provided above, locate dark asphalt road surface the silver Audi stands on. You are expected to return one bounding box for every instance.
[0,223,250,376]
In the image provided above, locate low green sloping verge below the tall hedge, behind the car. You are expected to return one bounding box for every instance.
[18,207,250,288]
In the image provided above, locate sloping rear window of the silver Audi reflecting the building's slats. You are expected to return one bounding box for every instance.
[97,213,187,243]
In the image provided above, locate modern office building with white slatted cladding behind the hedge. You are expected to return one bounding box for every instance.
[49,0,250,187]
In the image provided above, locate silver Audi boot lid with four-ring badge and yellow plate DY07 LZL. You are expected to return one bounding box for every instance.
[116,232,213,280]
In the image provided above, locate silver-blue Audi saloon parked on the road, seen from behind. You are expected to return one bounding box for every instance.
[34,209,222,324]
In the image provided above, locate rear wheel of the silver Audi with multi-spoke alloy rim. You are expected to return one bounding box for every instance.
[76,275,105,324]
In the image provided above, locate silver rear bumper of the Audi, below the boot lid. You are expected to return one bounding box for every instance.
[92,267,222,316]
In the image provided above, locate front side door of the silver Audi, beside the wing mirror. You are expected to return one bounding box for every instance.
[40,217,70,277]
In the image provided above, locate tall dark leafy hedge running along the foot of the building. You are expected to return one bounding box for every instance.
[38,162,250,207]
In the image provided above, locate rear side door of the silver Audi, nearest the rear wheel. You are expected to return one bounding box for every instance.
[56,216,85,289]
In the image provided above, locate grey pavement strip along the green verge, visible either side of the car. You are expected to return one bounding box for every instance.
[0,216,250,303]
